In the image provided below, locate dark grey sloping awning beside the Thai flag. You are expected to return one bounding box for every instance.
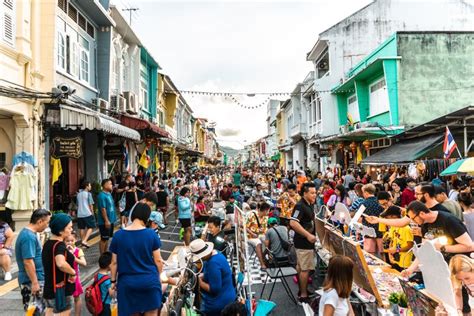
[362,135,443,165]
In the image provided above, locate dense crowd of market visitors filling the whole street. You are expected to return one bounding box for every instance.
[0,167,474,315]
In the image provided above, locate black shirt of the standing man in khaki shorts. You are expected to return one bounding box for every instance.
[291,199,315,249]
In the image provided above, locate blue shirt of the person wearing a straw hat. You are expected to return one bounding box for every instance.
[201,252,236,315]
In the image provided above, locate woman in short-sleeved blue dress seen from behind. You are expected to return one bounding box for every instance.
[110,203,163,316]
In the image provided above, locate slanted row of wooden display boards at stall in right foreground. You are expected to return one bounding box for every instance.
[315,214,452,316]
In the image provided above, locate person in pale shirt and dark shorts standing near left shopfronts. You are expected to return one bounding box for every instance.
[77,182,96,248]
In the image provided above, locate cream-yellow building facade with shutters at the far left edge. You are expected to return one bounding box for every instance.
[0,0,48,229]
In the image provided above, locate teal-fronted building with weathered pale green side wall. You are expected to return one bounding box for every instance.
[332,32,474,140]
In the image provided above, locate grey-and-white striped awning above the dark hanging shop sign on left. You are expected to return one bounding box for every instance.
[59,105,140,140]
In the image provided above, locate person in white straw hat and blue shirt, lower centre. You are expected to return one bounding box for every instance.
[189,239,236,316]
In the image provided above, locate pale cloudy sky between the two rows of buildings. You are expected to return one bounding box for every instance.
[121,0,371,148]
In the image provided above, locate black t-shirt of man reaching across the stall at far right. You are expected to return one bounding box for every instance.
[421,212,467,260]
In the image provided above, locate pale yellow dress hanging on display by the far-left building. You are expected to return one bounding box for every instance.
[5,164,36,210]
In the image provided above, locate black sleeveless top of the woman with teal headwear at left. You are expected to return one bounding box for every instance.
[41,239,76,300]
